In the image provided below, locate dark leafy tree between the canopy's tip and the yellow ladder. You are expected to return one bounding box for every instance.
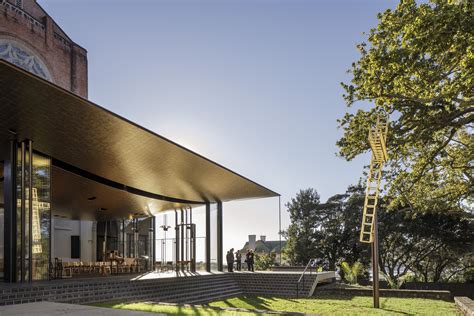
[284,186,369,270]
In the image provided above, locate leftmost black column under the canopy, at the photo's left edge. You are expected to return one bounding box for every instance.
[3,140,18,282]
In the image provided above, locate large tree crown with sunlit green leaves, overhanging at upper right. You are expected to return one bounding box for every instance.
[337,0,474,212]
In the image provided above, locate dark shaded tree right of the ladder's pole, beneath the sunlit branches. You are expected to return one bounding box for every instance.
[378,206,474,284]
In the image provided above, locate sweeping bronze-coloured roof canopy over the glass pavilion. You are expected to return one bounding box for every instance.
[0,61,278,216]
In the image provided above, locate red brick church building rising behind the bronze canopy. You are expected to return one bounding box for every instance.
[0,0,87,98]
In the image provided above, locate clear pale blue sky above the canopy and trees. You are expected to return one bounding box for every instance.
[38,0,397,256]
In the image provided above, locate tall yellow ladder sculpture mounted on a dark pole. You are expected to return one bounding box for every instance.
[360,114,388,243]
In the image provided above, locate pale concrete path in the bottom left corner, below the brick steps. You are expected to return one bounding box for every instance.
[0,302,164,316]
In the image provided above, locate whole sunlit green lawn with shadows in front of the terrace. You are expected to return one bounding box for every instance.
[96,293,461,316]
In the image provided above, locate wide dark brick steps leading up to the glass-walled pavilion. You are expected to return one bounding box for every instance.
[0,274,242,305]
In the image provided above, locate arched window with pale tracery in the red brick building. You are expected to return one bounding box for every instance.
[0,38,52,81]
